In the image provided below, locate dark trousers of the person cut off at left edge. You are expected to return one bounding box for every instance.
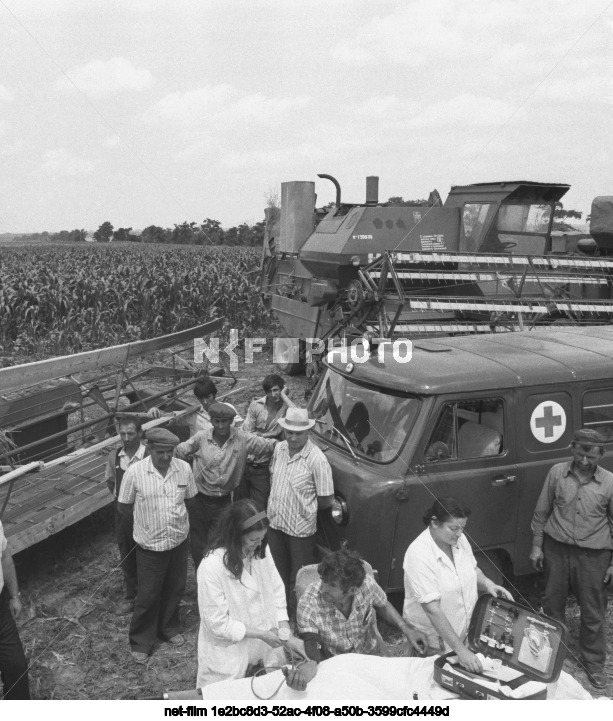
[0,586,30,701]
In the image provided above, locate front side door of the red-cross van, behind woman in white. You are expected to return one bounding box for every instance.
[389,391,518,588]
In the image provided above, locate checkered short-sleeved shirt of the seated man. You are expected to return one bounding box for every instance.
[297,575,387,656]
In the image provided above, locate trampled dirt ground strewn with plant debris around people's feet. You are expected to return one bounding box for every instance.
[9,348,613,699]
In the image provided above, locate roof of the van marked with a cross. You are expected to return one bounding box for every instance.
[328,326,613,395]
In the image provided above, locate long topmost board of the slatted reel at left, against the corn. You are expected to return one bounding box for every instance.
[0,318,223,393]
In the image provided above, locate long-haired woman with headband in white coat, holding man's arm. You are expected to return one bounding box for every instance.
[197,499,313,690]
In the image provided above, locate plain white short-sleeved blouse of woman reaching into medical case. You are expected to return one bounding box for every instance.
[403,528,478,648]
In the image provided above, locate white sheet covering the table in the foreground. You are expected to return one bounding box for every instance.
[202,653,592,701]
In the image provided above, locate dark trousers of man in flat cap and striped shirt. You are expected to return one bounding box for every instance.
[130,539,189,653]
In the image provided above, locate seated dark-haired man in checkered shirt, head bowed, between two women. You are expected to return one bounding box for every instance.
[297,549,427,663]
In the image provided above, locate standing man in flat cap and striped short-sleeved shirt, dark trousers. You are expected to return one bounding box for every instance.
[118,428,196,663]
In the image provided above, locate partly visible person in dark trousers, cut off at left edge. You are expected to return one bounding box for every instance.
[0,523,30,701]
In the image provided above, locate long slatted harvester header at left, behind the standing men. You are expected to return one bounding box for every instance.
[0,319,244,553]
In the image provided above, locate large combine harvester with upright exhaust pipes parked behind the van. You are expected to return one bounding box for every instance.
[261,175,613,373]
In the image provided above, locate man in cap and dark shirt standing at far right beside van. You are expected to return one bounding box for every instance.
[530,429,613,688]
